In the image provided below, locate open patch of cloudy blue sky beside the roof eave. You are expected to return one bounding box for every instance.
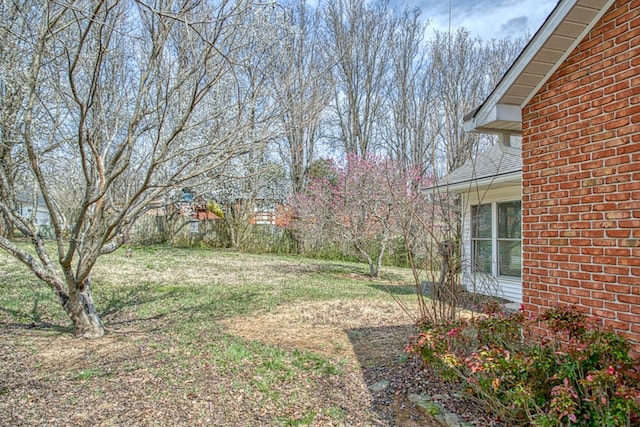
[412,0,557,40]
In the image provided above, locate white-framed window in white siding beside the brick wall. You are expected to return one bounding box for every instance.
[471,201,522,277]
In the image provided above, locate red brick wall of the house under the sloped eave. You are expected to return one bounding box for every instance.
[522,0,640,352]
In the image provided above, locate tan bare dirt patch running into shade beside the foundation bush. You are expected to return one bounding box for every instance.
[223,300,494,427]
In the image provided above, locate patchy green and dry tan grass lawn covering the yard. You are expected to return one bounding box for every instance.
[0,247,440,426]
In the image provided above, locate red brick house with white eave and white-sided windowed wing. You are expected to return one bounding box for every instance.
[450,0,640,352]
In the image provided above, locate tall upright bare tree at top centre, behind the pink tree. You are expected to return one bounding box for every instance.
[324,0,396,156]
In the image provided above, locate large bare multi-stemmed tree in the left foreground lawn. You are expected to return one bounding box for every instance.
[0,0,282,338]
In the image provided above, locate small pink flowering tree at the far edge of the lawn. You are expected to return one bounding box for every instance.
[291,155,427,277]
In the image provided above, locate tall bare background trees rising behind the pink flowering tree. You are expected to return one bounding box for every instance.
[130,0,525,254]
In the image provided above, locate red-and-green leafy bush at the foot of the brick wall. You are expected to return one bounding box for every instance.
[407,307,640,427]
